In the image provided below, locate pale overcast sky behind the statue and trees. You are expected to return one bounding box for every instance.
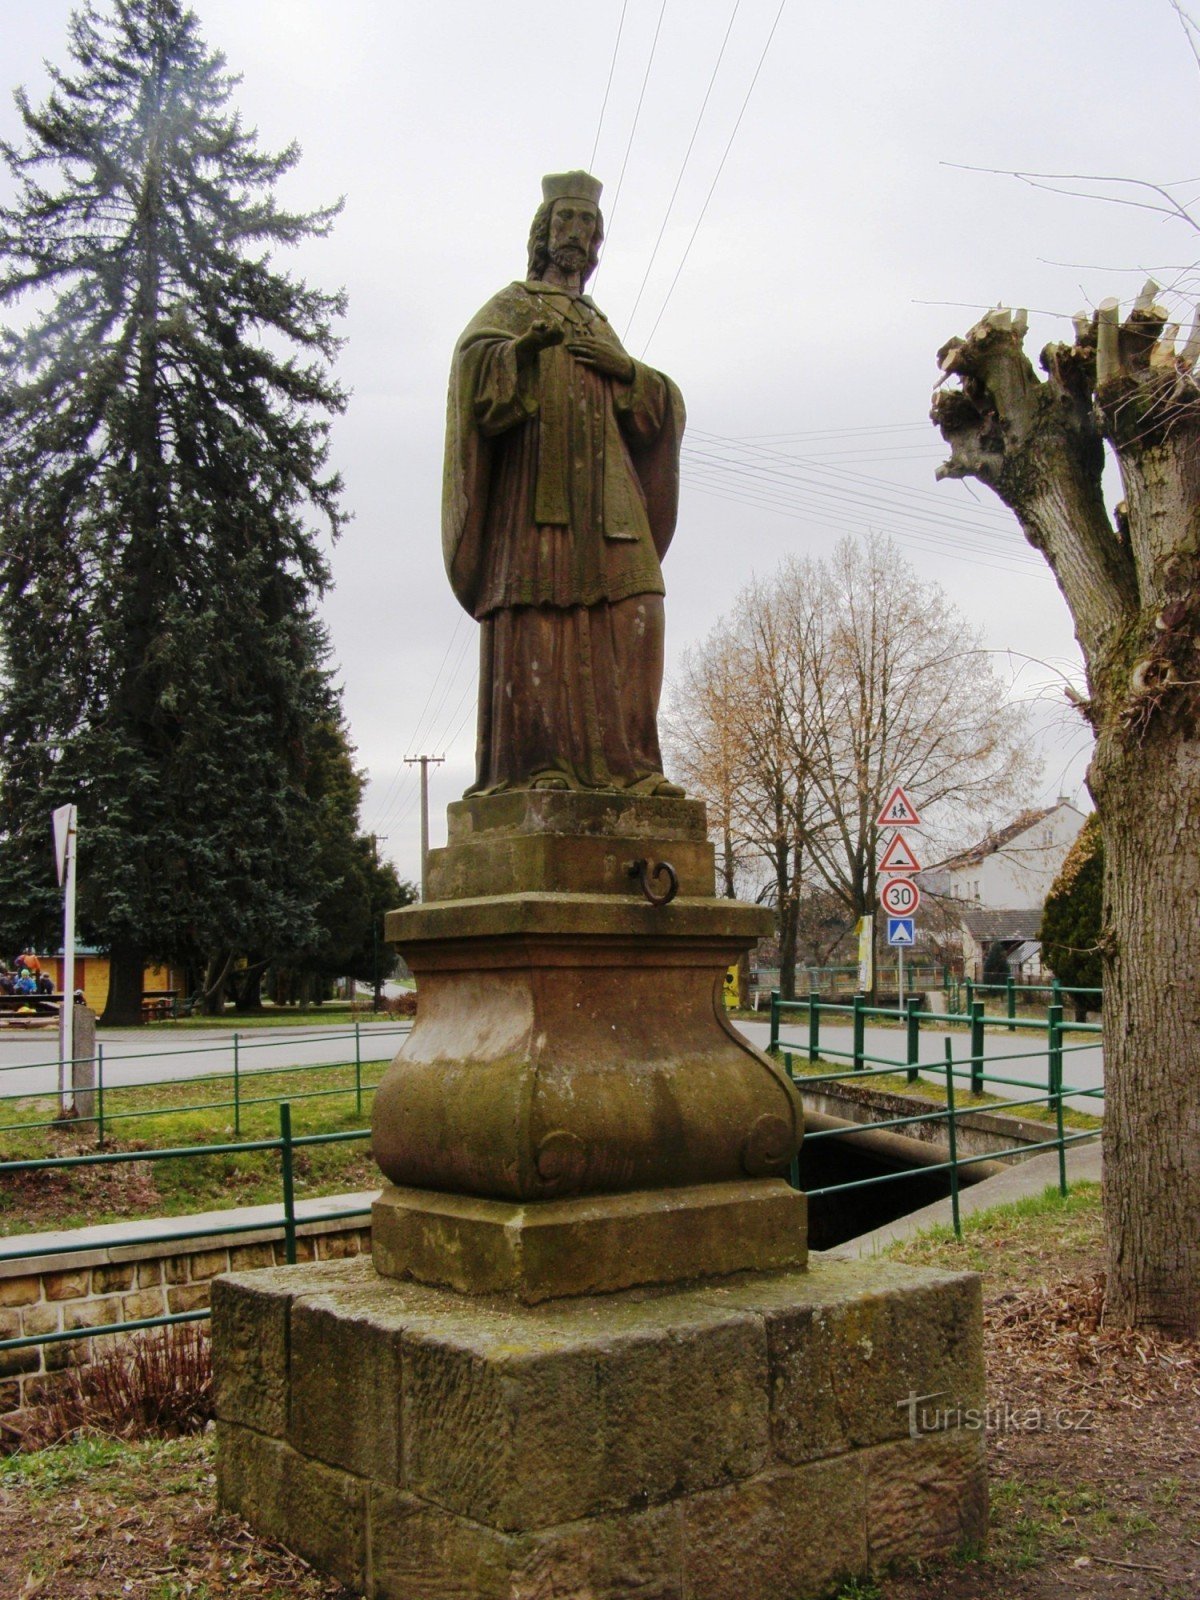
[0,0,1200,877]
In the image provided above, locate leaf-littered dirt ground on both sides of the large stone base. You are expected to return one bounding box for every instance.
[0,1187,1200,1600]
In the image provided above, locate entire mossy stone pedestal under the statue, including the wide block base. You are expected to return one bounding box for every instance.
[213,792,986,1600]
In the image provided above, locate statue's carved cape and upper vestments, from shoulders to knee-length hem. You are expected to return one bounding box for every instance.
[442,283,685,618]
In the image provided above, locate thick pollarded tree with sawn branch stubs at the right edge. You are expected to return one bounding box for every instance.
[933,285,1200,1334]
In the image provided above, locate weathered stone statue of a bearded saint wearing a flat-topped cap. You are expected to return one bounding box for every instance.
[442,173,683,795]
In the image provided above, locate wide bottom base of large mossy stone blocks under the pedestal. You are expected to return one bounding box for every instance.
[213,1261,987,1600]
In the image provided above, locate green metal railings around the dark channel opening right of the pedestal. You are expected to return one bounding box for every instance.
[768,990,1104,1237]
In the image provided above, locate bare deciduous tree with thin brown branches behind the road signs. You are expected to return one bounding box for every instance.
[667,538,1035,995]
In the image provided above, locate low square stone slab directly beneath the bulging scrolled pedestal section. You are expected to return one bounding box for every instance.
[371,1178,808,1304]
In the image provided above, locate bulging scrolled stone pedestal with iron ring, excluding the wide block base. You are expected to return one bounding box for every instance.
[373,790,805,1299]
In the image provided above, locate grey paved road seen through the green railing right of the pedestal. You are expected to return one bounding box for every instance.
[738,1014,1104,1115]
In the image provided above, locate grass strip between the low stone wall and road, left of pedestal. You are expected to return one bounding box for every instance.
[0,1061,387,1235]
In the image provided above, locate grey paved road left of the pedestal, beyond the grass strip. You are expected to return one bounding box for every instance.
[0,1018,410,1120]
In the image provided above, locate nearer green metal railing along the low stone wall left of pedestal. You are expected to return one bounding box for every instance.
[0,1101,371,1354]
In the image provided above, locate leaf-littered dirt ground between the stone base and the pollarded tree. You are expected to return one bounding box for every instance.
[889,1186,1200,1600]
